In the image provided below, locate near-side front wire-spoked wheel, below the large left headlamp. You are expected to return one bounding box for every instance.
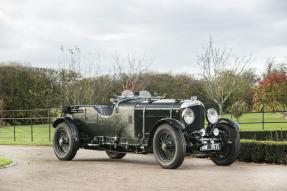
[153,124,186,169]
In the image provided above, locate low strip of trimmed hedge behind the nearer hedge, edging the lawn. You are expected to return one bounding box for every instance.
[240,130,287,141]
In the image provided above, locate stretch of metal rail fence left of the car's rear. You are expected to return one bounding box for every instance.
[0,108,61,144]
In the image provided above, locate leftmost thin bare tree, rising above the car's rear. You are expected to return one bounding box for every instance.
[59,46,100,105]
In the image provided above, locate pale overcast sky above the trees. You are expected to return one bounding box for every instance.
[0,0,287,73]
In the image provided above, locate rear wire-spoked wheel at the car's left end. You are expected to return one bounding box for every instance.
[53,123,78,160]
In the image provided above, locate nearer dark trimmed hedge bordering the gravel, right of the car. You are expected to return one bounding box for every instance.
[238,140,287,164]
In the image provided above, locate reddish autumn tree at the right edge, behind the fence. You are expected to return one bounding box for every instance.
[253,72,287,111]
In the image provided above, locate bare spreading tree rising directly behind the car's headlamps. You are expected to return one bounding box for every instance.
[197,38,253,114]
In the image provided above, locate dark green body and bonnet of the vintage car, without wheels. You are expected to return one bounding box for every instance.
[58,99,204,145]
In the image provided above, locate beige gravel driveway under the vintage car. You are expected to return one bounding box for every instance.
[0,145,287,191]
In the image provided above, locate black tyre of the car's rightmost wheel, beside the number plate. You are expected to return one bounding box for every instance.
[210,124,240,166]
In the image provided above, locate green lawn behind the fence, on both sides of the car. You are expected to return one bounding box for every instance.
[0,113,287,145]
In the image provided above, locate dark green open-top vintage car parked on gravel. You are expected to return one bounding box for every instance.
[53,90,240,169]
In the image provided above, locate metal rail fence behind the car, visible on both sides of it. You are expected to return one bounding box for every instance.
[0,108,287,144]
